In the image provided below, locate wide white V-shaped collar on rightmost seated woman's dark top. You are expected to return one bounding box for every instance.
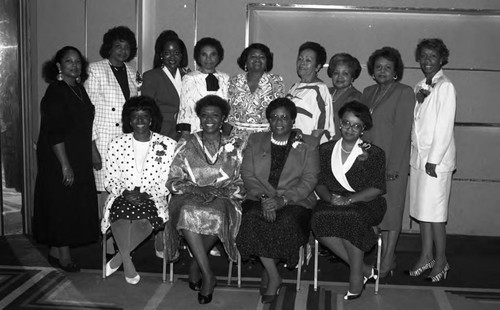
[331,138,363,192]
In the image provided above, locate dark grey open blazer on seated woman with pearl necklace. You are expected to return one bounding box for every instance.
[241,132,319,209]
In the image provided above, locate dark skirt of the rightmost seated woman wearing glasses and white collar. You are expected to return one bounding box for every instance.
[311,197,386,252]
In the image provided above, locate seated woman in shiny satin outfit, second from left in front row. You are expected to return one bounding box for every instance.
[165,95,244,304]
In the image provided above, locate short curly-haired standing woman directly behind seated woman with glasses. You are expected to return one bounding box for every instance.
[327,53,361,140]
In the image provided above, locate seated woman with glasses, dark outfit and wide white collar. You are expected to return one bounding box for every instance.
[311,101,386,300]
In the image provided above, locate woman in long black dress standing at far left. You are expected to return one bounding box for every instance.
[33,46,99,272]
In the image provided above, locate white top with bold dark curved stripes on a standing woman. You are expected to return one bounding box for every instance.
[287,82,335,143]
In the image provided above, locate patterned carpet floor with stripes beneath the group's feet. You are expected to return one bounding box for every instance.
[0,266,500,310]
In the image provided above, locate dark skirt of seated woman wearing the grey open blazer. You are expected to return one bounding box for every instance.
[236,200,312,266]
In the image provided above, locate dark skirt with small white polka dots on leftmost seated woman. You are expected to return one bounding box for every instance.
[109,196,163,229]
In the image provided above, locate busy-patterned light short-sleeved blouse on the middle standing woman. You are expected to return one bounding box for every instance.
[229,72,285,140]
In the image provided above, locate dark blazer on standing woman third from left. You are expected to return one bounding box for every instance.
[141,68,187,140]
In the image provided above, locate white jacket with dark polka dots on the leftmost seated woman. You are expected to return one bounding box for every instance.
[101,132,176,233]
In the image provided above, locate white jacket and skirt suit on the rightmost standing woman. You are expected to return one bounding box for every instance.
[410,70,456,223]
